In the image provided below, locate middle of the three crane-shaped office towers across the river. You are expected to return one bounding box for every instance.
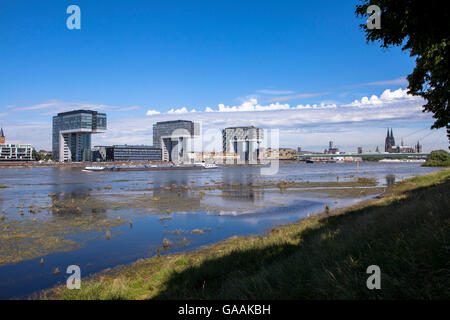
[153,120,200,162]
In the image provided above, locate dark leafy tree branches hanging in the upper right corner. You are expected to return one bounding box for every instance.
[356,0,450,140]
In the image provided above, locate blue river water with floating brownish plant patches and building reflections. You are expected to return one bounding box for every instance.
[0,162,442,299]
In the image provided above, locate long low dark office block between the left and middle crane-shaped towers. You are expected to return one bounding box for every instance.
[106,145,161,161]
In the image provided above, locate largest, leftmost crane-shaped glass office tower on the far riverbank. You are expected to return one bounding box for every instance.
[52,110,106,162]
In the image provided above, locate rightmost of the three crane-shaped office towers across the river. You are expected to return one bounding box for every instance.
[222,126,264,163]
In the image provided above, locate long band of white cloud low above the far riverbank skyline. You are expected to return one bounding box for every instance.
[0,89,446,149]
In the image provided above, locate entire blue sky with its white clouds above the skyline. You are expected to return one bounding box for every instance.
[0,0,447,151]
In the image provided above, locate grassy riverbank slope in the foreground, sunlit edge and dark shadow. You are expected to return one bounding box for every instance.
[37,170,450,299]
